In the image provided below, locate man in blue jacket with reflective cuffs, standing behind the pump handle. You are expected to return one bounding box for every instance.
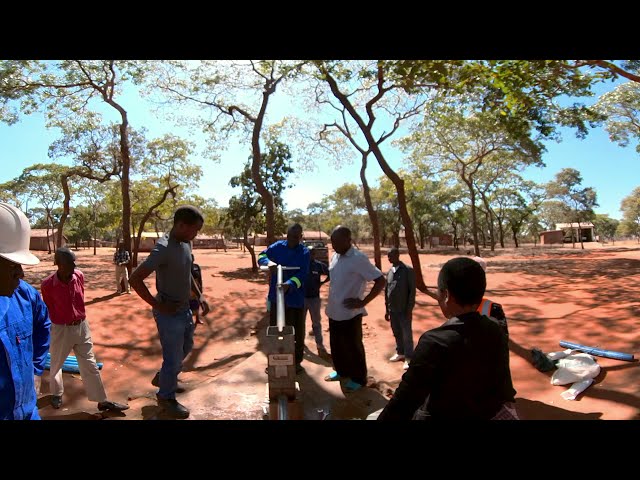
[258,223,310,373]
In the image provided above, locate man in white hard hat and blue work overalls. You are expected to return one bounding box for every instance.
[0,202,51,420]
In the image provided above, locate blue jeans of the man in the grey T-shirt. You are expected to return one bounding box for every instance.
[153,308,194,399]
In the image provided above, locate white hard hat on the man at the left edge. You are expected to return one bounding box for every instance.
[0,202,40,265]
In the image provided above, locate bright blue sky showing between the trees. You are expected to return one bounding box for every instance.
[0,75,640,218]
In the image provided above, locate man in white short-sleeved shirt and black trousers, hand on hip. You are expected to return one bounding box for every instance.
[325,226,386,393]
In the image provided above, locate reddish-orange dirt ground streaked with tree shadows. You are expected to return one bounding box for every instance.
[25,244,640,420]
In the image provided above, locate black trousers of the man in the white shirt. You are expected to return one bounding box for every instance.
[329,315,367,385]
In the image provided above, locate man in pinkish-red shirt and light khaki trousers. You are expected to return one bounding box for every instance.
[41,247,129,412]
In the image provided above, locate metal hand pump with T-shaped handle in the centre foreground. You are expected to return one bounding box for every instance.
[261,265,300,420]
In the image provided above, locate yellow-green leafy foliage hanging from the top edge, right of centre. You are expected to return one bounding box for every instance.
[386,60,602,137]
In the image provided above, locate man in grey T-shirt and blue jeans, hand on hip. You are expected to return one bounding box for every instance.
[129,205,209,418]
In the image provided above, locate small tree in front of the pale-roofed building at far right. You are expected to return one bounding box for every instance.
[547,168,598,249]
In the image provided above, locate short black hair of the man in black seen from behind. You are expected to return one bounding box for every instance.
[438,257,487,305]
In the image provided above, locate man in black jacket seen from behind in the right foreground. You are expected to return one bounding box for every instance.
[378,257,517,420]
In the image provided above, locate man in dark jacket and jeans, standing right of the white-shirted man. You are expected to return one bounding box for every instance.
[384,247,416,370]
